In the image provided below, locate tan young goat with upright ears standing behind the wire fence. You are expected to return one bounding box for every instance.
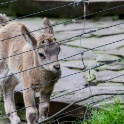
[0,14,61,124]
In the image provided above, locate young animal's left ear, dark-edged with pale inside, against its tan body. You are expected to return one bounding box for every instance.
[22,25,37,48]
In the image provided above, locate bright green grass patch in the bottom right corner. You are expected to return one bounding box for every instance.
[72,101,124,124]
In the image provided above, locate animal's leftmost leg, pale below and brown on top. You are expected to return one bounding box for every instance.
[3,77,21,124]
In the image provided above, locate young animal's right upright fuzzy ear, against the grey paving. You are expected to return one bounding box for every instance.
[43,17,54,34]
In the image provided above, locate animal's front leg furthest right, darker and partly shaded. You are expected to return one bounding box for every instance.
[39,91,52,122]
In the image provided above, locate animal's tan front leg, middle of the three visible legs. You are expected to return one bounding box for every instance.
[23,89,37,124]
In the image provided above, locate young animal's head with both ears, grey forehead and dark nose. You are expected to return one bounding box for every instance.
[22,18,60,73]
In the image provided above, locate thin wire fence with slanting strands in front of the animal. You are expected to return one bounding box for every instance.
[0,0,124,124]
